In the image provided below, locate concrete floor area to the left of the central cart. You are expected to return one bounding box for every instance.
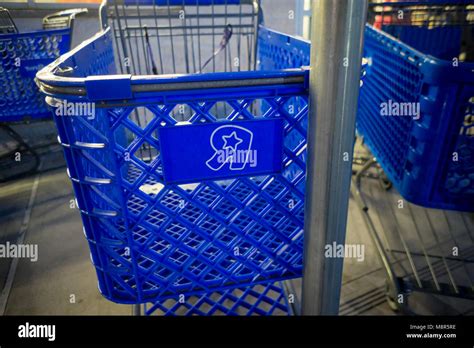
[0,136,131,315]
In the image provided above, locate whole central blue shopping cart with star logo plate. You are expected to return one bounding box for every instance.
[37,0,308,314]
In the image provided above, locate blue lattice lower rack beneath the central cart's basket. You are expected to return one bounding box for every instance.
[145,282,293,316]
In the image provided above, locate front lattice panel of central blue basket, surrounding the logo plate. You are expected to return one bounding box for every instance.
[97,82,307,302]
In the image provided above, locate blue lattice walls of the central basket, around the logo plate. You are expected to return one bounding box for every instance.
[43,27,307,303]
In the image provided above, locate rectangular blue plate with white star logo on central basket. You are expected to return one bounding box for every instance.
[158,119,283,184]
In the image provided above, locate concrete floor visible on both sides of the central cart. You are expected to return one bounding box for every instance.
[0,124,474,315]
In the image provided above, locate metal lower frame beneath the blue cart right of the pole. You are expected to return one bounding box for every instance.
[351,152,474,314]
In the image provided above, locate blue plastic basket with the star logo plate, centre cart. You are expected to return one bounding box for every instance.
[37,0,308,303]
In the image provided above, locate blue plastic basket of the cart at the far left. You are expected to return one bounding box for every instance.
[0,28,71,122]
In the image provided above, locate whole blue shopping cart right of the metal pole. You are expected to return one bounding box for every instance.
[353,0,474,310]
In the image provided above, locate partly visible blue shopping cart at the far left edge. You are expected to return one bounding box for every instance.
[0,8,86,180]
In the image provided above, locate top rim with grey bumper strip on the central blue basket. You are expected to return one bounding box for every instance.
[36,28,308,100]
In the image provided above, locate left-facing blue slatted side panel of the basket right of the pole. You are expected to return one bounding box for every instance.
[357,27,422,190]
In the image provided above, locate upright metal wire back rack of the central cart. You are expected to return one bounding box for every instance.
[102,0,262,161]
